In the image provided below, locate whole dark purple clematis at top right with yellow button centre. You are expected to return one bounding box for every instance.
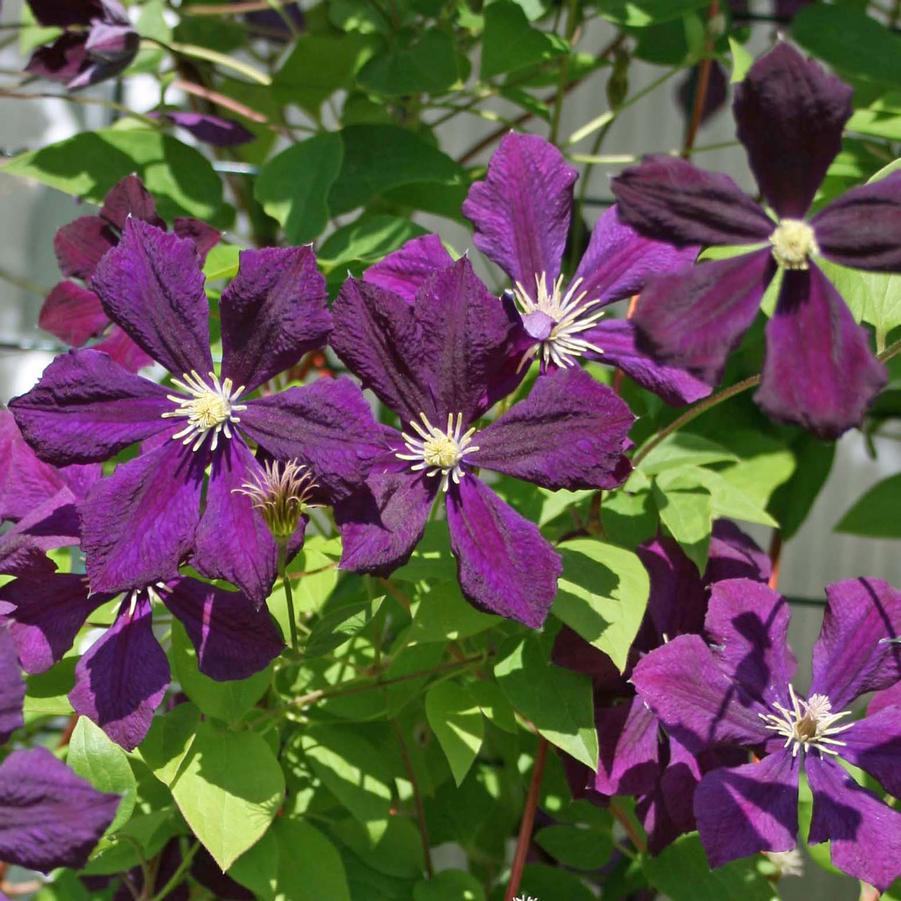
[613,43,901,437]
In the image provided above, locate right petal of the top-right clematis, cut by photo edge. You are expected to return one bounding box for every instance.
[811,172,901,272]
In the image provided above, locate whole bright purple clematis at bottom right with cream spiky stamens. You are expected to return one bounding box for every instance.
[632,579,901,890]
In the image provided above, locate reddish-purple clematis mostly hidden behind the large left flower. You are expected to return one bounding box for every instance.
[38,175,220,372]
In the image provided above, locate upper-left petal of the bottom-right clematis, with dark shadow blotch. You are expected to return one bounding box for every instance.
[704,579,797,706]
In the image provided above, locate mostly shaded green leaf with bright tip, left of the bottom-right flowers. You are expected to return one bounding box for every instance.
[494,636,598,770]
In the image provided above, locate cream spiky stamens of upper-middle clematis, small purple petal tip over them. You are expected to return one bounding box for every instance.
[513,272,605,369]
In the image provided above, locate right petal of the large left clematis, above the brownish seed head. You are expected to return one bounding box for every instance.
[241,378,384,498]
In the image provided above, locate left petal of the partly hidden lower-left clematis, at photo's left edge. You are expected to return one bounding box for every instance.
[0,573,110,673]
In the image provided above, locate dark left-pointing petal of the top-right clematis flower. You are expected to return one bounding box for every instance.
[611,154,776,247]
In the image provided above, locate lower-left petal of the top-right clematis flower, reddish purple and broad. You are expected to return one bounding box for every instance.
[635,250,776,385]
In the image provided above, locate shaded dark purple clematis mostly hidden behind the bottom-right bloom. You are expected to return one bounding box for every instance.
[553,520,770,854]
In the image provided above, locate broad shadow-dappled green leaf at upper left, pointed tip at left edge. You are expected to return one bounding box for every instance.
[0,128,222,220]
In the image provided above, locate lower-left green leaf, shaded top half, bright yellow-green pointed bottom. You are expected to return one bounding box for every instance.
[171,722,285,870]
